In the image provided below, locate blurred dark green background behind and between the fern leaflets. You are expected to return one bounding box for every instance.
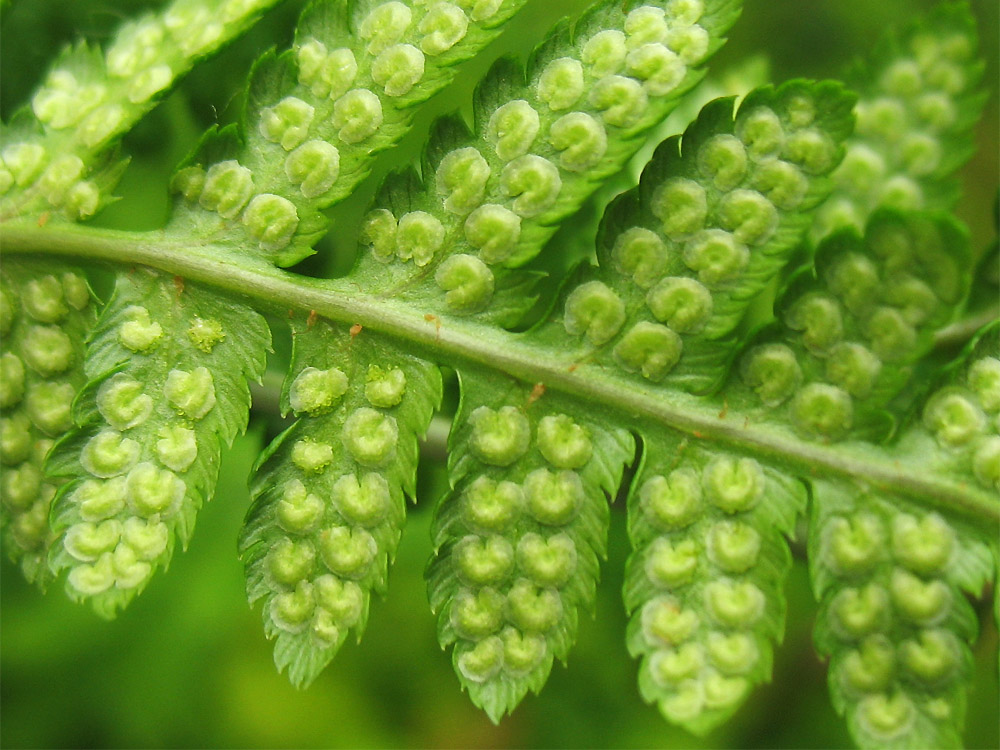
[0,0,1000,748]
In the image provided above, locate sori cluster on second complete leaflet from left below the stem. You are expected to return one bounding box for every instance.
[258,365,406,648]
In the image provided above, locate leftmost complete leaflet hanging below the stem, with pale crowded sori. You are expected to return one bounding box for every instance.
[49,268,270,617]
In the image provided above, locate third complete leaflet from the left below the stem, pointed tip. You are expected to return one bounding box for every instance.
[427,371,634,722]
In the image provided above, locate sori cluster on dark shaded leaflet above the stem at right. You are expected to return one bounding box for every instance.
[740,214,965,440]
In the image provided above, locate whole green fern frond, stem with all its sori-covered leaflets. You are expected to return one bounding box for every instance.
[0,0,1000,748]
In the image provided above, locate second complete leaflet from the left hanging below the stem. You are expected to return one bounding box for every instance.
[240,317,441,687]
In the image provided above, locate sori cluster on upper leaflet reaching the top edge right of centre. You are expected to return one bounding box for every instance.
[362,0,720,313]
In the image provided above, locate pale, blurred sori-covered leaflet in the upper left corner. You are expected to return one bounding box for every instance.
[0,0,274,220]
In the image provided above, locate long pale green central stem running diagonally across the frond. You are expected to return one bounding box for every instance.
[0,222,1000,524]
